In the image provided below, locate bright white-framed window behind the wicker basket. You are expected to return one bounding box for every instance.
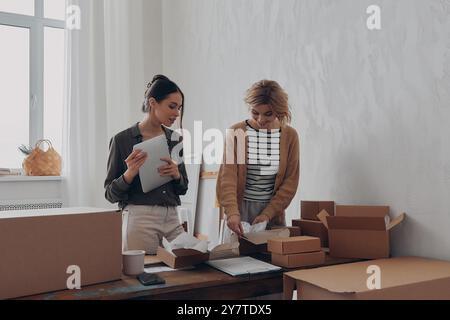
[0,0,66,168]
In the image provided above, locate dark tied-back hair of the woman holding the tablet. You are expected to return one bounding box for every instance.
[142,74,184,127]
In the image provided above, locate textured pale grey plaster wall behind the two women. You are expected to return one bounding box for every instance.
[162,0,450,259]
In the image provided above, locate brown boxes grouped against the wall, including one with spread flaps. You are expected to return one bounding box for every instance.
[292,201,406,259]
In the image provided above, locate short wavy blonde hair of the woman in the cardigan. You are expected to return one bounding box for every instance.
[244,80,292,126]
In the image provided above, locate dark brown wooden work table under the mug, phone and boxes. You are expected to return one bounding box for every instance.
[25,255,357,300]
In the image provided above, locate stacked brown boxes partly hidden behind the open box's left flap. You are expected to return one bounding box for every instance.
[292,201,334,248]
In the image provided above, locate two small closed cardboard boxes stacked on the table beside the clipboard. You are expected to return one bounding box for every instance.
[267,236,325,268]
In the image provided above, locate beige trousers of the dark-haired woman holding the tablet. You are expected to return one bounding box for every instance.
[122,204,184,254]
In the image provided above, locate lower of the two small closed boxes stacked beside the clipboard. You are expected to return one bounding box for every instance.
[272,251,325,268]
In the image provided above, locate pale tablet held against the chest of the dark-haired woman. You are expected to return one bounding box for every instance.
[133,134,173,193]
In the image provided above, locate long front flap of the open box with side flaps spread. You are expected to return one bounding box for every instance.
[327,216,386,231]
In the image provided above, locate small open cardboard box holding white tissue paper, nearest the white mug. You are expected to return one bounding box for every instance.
[156,247,209,269]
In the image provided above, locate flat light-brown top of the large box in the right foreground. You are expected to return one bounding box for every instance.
[285,257,450,293]
